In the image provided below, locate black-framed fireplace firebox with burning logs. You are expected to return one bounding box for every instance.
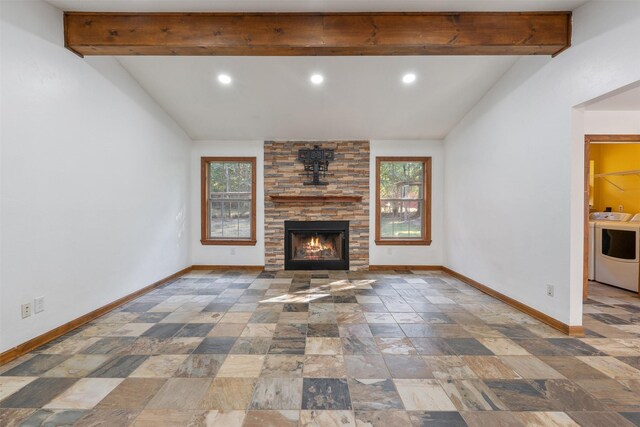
[284,221,349,270]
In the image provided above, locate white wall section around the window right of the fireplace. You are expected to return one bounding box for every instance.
[369,140,444,265]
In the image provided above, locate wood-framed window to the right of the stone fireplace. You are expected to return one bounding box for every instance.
[376,157,431,245]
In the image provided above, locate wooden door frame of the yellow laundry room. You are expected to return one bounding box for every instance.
[582,134,640,302]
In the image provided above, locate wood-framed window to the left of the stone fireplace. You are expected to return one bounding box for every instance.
[200,157,256,245]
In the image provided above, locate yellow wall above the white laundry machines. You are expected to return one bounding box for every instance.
[590,143,640,214]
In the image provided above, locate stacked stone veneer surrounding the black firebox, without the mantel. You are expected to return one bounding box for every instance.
[264,141,369,270]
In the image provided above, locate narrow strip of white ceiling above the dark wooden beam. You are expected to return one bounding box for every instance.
[48,0,587,12]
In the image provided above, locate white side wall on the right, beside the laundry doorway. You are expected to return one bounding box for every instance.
[444,1,640,325]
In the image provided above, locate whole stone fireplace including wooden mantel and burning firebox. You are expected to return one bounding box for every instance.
[264,141,370,270]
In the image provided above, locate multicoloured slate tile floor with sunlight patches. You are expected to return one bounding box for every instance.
[0,271,640,427]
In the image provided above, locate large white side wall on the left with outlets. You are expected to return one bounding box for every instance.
[0,1,190,351]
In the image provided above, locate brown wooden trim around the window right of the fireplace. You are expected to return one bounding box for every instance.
[375,157,431,246]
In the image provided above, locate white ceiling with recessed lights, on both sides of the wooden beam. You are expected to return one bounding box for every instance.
[49,0,586,140]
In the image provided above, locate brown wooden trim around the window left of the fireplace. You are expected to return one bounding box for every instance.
[200,157,256,246]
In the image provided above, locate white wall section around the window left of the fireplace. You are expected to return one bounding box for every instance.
[190,141,264,265]
